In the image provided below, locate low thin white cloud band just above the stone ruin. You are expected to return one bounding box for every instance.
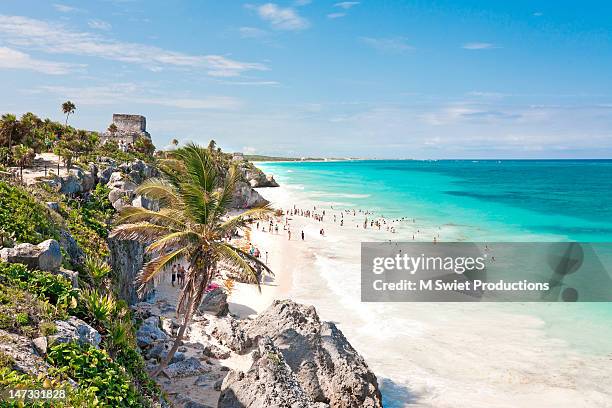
[35,82,242,110]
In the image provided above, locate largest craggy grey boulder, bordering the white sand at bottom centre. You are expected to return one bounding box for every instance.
[243,300,382,408]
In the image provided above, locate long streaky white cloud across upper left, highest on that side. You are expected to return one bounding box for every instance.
[0,15,268,77]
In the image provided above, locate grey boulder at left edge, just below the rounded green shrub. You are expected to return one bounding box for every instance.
[0,239,62,272]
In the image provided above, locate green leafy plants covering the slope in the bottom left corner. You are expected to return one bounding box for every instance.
[0,262,161,407]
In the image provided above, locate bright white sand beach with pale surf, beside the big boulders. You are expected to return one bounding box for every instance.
[229,186,612,407]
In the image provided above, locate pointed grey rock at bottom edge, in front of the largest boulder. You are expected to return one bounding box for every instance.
[217,338,329,408]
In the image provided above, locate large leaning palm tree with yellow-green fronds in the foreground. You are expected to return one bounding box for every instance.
[111,144,272,376]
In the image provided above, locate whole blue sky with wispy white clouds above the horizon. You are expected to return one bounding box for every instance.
[0,0,612,159]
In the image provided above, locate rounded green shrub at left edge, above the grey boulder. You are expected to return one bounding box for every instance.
[0,181,58,244]
